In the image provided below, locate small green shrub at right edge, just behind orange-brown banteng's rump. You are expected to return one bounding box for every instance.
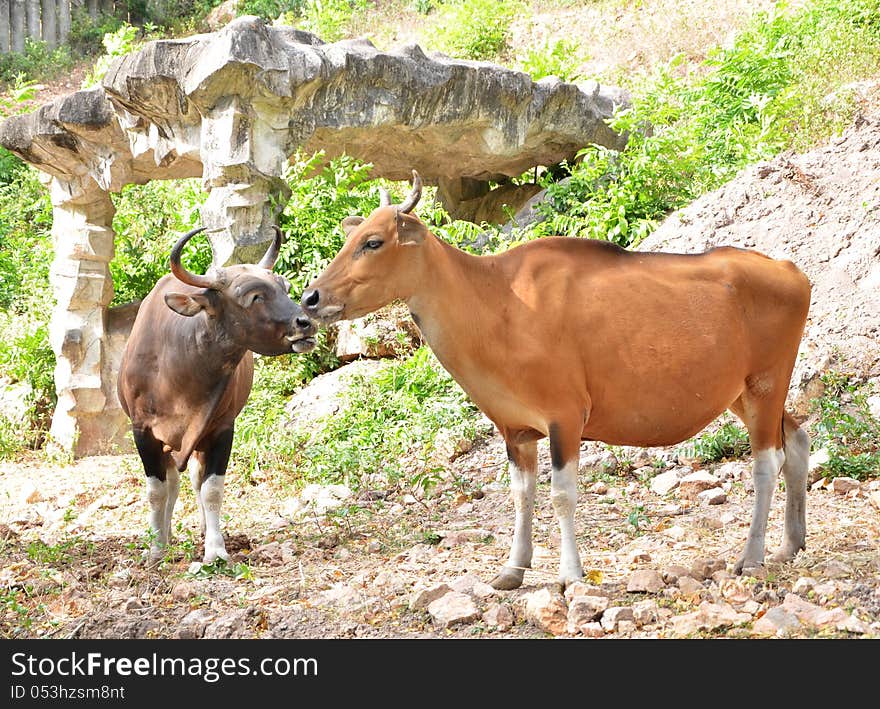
[812,371,880,480]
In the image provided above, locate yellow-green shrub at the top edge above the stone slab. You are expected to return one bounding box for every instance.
[427,0,523,60]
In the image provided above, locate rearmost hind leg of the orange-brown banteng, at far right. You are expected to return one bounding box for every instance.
[770,413,810,562]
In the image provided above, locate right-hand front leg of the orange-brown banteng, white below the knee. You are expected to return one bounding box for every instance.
[550,423,584,587]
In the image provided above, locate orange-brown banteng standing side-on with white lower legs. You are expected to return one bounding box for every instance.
[302,172,810,589]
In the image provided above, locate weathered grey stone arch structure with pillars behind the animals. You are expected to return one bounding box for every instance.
[0,17,627,455]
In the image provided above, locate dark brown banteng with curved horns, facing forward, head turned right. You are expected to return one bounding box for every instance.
[117,227,315,565]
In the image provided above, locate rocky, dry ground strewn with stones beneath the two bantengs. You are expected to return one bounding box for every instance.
[0,428,880,638]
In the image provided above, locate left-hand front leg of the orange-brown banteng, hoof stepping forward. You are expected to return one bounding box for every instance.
[490,441,538,591]
